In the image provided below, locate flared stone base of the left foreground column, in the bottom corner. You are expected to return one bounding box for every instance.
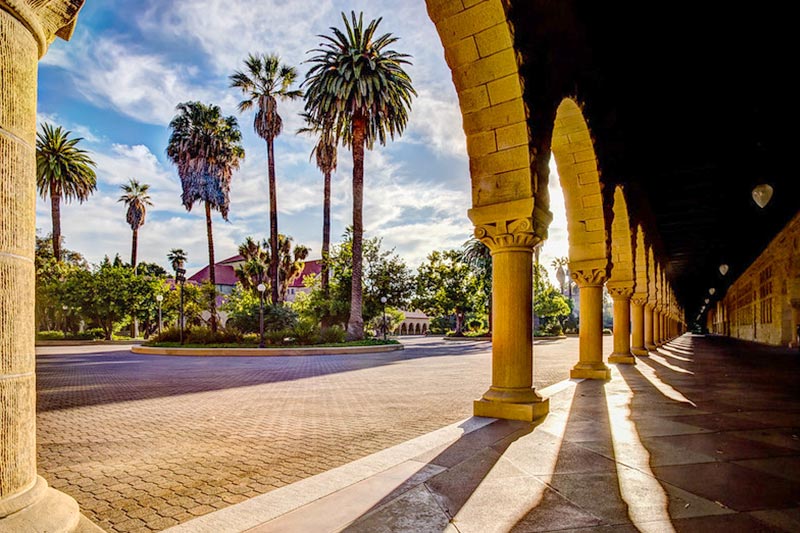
[0,476,103,533]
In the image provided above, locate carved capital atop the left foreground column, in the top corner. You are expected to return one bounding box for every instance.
[0,0,85,58]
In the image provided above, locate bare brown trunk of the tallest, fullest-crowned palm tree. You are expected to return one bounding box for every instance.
[347,116,366,340]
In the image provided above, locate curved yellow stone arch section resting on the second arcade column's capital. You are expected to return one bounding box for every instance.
[548,98,608,275]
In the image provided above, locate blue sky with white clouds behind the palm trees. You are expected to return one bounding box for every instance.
[37,0,567,282]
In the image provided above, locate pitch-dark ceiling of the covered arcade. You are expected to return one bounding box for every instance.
[509,0,800,318]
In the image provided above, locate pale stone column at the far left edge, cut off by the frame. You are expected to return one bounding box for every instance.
[0,0,99,532]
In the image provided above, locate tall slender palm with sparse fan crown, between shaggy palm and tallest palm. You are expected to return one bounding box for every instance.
[230,54,303,304]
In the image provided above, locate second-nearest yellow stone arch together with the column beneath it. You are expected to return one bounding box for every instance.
[547,98,612,379]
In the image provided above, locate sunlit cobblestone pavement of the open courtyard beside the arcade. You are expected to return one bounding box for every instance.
[37,337,611,532]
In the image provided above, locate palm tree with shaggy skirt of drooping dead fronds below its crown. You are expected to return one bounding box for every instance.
[167,102,244,331]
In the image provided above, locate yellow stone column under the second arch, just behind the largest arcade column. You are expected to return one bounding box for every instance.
[569,263,611,379]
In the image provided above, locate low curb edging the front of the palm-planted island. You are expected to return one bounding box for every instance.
[131,344,405,357]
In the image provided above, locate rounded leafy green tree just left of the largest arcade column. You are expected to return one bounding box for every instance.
[413,250,479,335]
